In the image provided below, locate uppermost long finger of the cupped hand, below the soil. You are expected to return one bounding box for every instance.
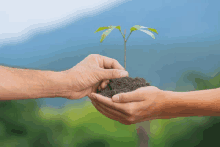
[90,93,129,115]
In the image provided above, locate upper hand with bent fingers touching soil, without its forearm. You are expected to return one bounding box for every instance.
[62,54,128,99]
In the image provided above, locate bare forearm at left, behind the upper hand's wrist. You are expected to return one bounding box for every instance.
[0,66,69,100]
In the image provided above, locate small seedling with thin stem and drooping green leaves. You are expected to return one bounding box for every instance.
[95,25,158,70]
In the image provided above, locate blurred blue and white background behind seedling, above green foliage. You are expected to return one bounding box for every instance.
[0,0,220,108]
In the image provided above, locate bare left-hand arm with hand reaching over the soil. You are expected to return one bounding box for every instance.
[0,54,128,100]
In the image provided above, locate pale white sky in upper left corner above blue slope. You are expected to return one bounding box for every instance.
[0,0,129,43]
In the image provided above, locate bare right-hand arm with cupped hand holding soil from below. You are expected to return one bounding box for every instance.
[89,86,220,125]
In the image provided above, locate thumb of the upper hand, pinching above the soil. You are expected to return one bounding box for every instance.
[101,69,129,80]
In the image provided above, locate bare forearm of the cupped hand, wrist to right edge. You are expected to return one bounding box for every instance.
[161,88,220,118]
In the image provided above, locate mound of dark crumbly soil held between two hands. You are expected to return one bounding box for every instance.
[97,77,151,98]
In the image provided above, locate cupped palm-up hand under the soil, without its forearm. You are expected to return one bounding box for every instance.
[89,86,168,125]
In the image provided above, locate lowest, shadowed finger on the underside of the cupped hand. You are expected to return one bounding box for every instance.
[92,101,129,125]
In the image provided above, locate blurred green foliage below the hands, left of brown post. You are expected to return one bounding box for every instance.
[0,100,138,147]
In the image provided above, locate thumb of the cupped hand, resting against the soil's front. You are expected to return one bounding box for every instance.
[112,90,145,103]
